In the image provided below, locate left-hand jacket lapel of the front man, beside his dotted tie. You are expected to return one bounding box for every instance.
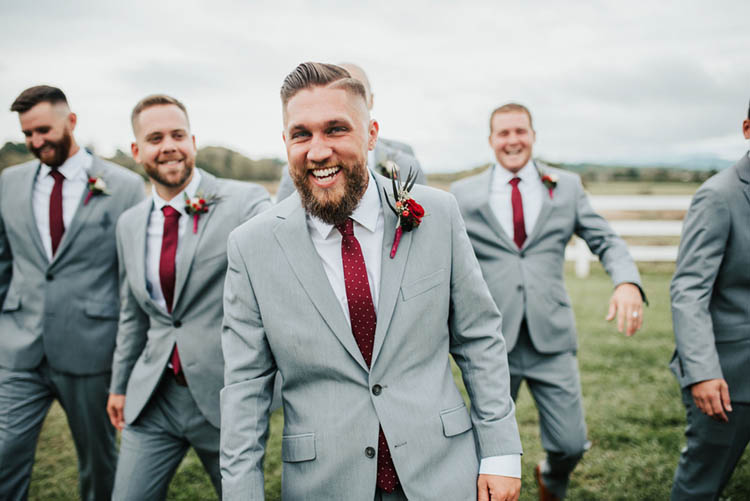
[274,203,370,371]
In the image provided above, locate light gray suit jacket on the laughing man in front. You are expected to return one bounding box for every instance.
[221,176,521,500]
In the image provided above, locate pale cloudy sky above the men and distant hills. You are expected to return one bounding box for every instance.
[0,0,750,172]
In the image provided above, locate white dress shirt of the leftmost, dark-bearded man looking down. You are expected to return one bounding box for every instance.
[31,148,93,261]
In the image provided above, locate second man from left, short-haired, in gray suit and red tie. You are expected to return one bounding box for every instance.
[107,95,271,501]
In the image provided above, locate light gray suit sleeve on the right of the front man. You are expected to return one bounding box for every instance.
[450,197,522,458]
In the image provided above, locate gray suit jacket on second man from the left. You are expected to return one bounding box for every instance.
[111,171,271,427]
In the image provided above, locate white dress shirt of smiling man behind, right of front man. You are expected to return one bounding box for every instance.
[490,160,546,240]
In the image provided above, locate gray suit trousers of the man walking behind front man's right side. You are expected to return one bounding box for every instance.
[508,321,590,499]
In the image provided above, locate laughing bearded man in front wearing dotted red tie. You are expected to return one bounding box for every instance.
[221,63,521,501]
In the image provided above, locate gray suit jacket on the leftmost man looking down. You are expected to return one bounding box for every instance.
[0,157,144,375]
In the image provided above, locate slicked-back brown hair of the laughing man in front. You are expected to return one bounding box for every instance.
[281,62,367,109]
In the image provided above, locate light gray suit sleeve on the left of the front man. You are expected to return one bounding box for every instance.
[220,233,276,501]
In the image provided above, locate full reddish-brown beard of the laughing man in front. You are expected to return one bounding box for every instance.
[290,160,368,226]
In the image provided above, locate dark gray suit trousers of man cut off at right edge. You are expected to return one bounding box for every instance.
[672,387,750,501]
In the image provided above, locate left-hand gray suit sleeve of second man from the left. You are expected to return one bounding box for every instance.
[109,219,149,395]
